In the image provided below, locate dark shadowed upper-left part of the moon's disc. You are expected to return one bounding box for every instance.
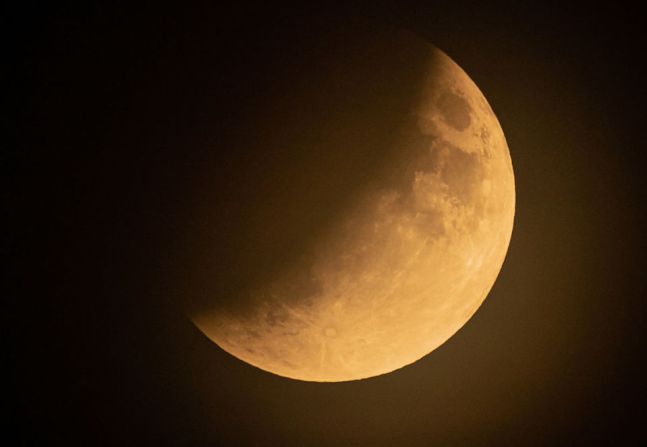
[180,26,440,324]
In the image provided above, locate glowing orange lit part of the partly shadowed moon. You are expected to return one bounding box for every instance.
[191,38,515,382]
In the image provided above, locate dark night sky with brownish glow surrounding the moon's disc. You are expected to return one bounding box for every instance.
[10,2,647,446]
